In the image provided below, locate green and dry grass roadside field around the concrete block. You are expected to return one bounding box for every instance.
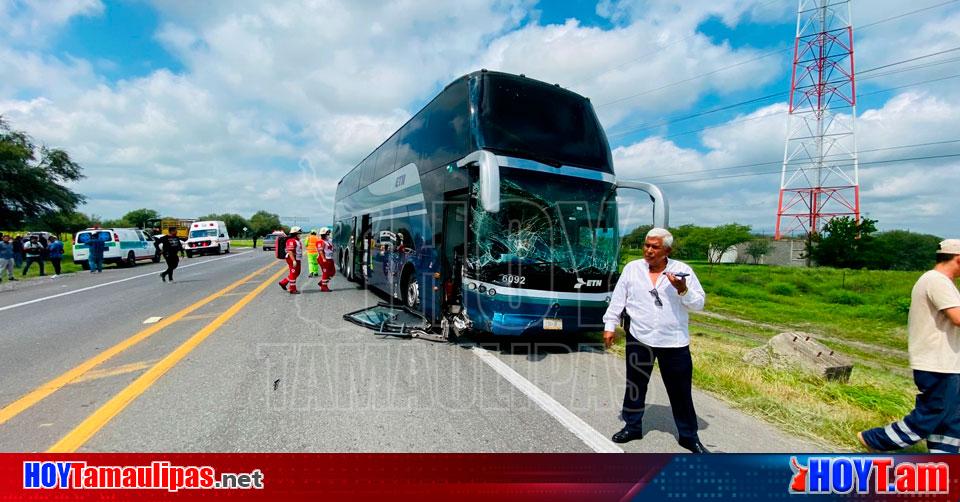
[600,256,925,451]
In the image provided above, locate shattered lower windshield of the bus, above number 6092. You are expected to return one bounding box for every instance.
[468,169,618,275]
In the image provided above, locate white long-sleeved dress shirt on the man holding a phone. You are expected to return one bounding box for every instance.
[603,258,707,347]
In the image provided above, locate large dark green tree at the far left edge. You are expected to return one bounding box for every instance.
[0,117,85,228]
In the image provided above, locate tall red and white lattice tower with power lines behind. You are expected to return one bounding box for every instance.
[776,0,860,239]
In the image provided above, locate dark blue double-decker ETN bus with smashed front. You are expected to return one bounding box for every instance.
[333,70,667,335]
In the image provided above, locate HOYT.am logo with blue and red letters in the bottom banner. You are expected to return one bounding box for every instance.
[790,457,950,495]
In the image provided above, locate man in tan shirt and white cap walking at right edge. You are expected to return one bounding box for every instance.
[857,239,960,453]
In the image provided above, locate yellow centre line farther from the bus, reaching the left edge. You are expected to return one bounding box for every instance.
[0,263,275,425]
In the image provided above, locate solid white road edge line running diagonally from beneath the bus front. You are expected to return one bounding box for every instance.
[471,345,623,453]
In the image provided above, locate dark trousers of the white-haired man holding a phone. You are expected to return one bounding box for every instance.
[623,340,698,440]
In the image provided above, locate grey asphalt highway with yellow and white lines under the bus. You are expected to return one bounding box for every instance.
[0,249,823,453]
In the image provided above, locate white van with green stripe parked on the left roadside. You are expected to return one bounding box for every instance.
[73,228,160,270]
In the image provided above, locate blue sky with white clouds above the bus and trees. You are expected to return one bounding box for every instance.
[0,0,960,235]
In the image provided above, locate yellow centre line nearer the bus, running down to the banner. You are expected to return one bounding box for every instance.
[47,268,287,453]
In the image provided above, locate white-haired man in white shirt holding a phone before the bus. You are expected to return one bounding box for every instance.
[603,228,710,453]
